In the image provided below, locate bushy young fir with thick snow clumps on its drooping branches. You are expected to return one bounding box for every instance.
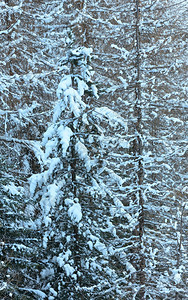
[30,48,129,299]
